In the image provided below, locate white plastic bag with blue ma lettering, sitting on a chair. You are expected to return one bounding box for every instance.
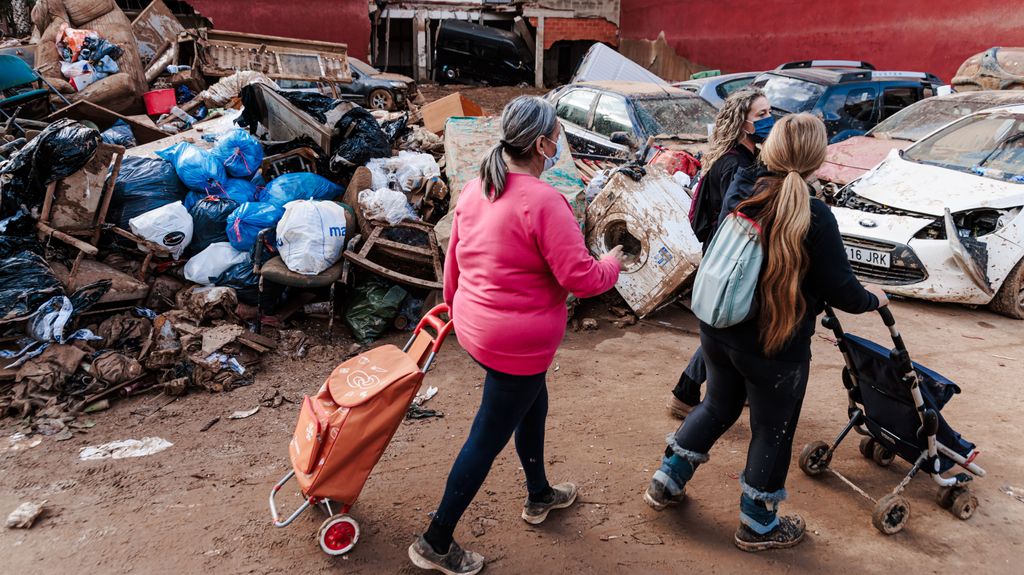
[278,200,350,275]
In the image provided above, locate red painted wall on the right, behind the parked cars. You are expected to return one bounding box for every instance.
[620,0,1024,82]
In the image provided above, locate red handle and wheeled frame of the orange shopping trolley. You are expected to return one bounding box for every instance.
[269,304,453,556]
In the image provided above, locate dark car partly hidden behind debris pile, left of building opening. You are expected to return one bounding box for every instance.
[278,57,420,110]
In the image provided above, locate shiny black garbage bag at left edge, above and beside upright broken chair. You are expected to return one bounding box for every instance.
[0,118,100,215]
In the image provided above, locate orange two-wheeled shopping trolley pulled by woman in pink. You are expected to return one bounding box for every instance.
[270,304,452,556]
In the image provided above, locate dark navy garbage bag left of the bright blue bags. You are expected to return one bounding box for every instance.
[106,156,188,229]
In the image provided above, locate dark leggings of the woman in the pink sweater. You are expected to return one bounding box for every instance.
[434,365,550,533]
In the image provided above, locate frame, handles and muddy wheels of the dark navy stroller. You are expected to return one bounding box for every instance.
[799,305,985,535]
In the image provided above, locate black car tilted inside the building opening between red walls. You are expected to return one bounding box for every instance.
[434,19,534,86]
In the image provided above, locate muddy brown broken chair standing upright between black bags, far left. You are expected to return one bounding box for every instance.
[36,142,170,312]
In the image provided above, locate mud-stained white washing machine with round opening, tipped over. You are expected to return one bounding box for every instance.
[586,169,700,318]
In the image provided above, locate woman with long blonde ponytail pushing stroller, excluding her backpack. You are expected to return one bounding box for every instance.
[644,114,888,551]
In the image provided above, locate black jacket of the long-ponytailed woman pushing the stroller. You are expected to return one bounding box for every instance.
[700,165,879,361]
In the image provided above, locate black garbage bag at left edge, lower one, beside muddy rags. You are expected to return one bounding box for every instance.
[0,250,63,322]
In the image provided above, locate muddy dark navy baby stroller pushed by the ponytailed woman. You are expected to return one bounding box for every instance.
[800,306,985,535]
